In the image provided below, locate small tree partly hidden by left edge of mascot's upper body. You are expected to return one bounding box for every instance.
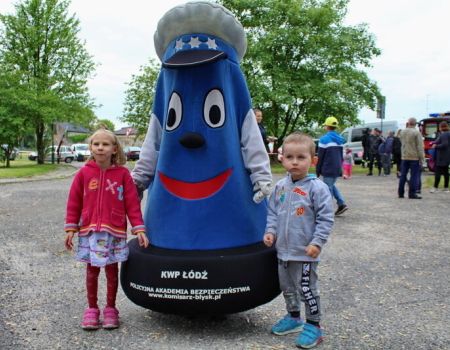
[120,59,160,137]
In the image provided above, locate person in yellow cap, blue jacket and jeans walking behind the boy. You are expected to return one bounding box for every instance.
[316,117,348,215]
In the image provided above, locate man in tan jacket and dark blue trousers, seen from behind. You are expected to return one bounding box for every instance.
[398,118,425,199]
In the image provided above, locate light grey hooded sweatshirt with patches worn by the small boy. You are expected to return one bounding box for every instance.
[266,175,334,262]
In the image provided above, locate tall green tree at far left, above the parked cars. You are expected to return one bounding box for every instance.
[0,0,94,163]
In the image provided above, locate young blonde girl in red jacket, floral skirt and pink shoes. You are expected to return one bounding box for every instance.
[64,129,149,329]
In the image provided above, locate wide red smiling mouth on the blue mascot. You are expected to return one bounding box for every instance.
[159,168,233,199]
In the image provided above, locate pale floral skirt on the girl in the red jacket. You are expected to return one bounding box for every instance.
[76,232,128,267]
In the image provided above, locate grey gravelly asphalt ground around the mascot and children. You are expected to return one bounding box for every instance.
[0,171,450,350]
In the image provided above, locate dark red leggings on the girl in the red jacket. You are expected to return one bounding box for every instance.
[86,263,119,308]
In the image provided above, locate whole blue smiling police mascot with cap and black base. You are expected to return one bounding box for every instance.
[121,1,279,314]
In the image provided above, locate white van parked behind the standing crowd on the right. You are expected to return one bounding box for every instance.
[341,120,400,164]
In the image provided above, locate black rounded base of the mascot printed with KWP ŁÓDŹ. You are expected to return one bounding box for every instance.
[120,239,280,315]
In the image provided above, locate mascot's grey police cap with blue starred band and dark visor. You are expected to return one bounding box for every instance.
[153,1,247,68]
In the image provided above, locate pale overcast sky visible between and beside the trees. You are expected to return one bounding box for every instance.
[0,0,450,128]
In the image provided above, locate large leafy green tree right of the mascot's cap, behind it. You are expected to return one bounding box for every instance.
[218,0,380,144]
